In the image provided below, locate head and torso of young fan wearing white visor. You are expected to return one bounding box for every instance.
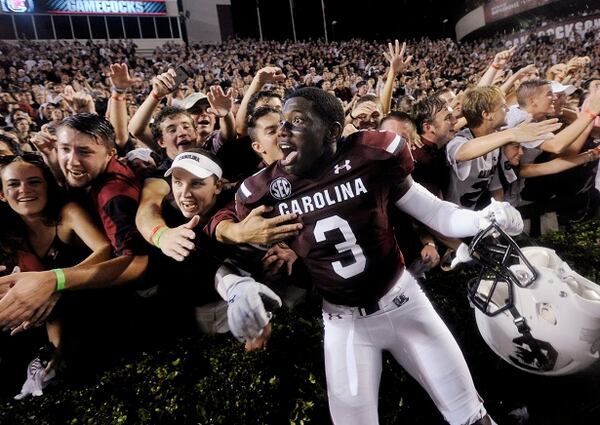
[148,148,231,333]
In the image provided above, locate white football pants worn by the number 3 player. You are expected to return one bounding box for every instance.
[323,270,486,425]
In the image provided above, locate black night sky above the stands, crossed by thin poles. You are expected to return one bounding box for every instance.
[231,0,465,41]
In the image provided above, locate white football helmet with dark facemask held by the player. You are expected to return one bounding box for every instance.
[468,224,600,375]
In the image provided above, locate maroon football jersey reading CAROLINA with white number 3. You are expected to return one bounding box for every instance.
[236,131,413,306]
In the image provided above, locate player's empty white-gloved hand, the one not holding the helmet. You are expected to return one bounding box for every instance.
[227,277,281,341]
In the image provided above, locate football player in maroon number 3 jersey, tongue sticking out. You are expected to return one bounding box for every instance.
[220,88,523,425]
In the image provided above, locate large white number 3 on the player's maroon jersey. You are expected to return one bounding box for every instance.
[313,215,367,279]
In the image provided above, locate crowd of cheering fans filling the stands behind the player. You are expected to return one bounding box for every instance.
[0,10,600,414]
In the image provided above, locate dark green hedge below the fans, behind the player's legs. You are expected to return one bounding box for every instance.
[0,222,600,425]
